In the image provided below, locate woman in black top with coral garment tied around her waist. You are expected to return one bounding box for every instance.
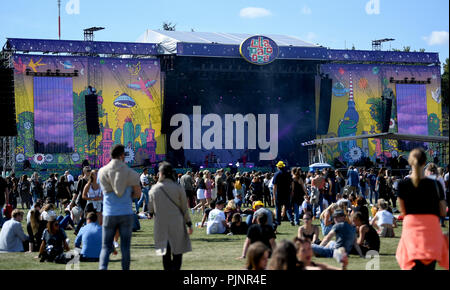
[396,148,449,270]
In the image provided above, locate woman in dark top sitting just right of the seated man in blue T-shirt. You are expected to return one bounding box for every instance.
[352,211,380,257]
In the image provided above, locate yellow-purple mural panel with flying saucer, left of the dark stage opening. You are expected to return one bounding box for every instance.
[14,55,166,169]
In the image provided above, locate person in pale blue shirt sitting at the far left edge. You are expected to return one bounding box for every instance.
[0,209,29,252]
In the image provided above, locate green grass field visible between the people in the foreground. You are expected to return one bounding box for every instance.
[0,207,448,270]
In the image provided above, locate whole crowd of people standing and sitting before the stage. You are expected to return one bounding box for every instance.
[0,145,449,270]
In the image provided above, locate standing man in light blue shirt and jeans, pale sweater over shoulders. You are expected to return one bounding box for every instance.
[98,144,141,270]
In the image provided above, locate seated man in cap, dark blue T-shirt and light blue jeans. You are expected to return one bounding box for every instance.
[312,210,355,258]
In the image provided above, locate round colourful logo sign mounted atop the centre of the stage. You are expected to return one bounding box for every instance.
[239,35,279,65]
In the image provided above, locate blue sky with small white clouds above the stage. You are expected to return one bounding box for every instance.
[0,0,449,62]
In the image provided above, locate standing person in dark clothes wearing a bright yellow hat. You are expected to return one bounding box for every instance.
[273,161,294,225]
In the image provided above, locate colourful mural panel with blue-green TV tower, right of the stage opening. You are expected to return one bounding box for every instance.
[321,64,442,164]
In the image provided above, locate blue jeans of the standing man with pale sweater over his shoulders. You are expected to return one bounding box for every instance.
[99,215,134,270]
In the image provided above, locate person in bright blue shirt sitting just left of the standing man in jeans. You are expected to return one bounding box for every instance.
[75,212,102,262]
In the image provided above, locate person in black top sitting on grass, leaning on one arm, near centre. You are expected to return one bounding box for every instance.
[238,213,276,259]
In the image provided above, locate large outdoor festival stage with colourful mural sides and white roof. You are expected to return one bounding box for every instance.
[1,30,442,177]
